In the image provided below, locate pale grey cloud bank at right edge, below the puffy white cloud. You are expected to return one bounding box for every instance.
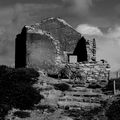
[97,37,120,71]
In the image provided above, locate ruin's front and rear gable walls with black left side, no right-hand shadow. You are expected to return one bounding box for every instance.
[16,18,81,69]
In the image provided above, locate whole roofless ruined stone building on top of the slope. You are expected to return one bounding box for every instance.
[15,18,96,69]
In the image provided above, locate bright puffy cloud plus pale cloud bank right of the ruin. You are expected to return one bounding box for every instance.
[76,24,120,71]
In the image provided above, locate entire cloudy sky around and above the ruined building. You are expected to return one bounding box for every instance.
[0,0,120,70]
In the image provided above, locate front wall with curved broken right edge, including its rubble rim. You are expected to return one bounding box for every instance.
[26,28,61,70]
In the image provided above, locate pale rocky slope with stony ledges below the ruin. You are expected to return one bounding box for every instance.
[6,75,108,120]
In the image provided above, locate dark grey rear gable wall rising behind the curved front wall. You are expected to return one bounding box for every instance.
[29,18,81,52]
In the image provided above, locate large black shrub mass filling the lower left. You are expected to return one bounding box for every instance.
[0,66,43,119]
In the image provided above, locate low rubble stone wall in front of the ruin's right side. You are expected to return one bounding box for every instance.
[59,61,110,87]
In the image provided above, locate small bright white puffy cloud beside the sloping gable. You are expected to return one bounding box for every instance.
[76,24,103,35]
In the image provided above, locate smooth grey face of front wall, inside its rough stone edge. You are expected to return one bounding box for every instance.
[26,33,58,68]
